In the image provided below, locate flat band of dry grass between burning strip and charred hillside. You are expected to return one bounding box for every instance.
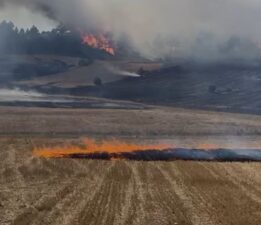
[0,107,261,137]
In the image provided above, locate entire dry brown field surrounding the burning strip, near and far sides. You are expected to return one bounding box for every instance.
[0,104,261,225]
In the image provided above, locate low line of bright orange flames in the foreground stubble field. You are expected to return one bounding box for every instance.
[33,139,170,158]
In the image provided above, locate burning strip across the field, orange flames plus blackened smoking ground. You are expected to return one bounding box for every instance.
[33,139,261,161]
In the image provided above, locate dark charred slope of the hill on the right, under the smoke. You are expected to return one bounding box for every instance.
[63,63,261,113]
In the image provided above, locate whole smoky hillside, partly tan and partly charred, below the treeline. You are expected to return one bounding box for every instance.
[3,55,261,114]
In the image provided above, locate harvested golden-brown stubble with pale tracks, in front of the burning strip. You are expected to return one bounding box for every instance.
[0,138,261,225]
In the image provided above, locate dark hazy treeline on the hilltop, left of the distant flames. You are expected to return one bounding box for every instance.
[0,21,109,58]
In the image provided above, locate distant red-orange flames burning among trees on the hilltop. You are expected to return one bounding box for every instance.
[82,34,115,55]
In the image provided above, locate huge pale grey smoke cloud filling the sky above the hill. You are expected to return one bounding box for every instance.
[0,0,261,61]
